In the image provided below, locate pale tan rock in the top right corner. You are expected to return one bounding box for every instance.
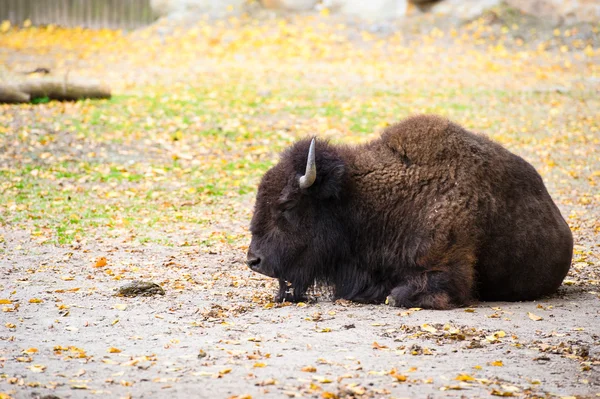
[506,0,600,24]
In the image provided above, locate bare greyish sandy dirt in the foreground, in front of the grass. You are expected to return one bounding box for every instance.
[0,223,600,398]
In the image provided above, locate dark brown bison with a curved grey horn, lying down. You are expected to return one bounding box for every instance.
[247,116,573,309]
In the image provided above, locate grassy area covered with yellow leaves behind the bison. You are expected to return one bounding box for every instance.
[0,17,600,247]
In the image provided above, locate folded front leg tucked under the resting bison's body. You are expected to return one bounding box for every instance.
[387,271,469,309]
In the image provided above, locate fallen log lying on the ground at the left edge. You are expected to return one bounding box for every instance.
[0,78,111,103]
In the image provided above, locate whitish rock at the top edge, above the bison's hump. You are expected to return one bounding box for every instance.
[326,0,408,19]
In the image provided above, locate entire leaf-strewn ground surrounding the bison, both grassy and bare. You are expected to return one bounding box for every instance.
[0,5,600,399]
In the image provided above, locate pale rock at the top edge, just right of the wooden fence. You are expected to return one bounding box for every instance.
[150,0,245,17]
